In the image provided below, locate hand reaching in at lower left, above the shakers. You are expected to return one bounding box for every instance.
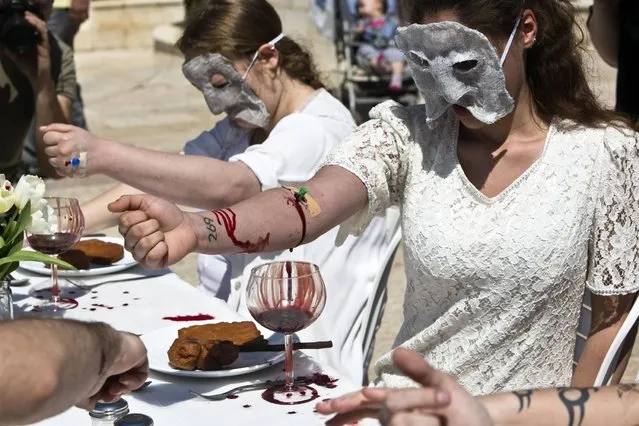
[76,332,149,410]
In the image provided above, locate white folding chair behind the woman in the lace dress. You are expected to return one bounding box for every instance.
[573,290,639,386]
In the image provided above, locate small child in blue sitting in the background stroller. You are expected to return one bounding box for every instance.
[354,0,404,91]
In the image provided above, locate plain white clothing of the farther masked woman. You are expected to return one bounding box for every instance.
[184,90,398,383]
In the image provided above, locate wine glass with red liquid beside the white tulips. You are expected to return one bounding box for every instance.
[26,197,84,312]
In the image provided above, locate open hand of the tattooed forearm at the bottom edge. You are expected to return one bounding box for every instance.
[317,348,493,426]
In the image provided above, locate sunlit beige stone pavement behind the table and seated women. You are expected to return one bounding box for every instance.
[41,12,639,378]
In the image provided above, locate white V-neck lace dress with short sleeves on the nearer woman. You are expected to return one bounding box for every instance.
[324,101,639,394]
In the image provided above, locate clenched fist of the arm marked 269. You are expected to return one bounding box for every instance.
[109,195,197,268]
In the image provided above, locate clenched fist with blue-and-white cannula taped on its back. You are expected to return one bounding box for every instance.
[40,123,105,177]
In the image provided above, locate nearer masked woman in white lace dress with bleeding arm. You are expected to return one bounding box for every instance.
[112,0,639,394]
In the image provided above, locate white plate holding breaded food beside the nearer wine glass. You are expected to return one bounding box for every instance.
[145,319,284,378]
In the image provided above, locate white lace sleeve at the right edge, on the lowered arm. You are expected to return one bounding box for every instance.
[587,128,639,295]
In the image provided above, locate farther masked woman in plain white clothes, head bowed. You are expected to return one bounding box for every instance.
[44,0,390,383]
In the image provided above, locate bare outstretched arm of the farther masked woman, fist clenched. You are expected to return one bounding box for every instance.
[40,124,261,209]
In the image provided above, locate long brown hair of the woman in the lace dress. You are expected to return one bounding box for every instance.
[400,0,637,129]
